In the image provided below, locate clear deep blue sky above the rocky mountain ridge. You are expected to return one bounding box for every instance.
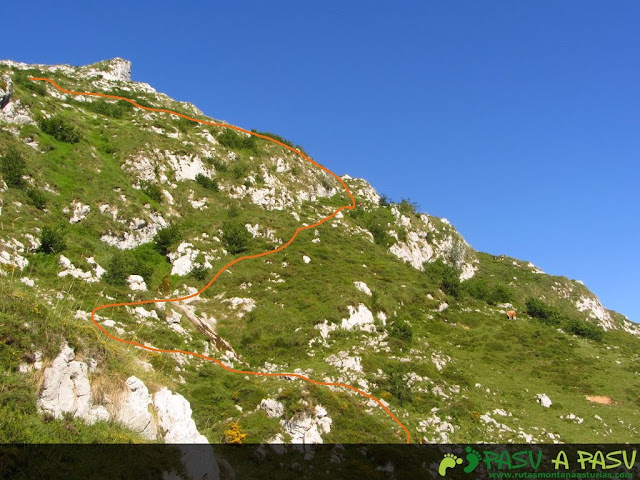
[0,0,640,321]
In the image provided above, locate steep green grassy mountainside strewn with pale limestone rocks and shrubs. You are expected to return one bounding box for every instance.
[0,54,640,464]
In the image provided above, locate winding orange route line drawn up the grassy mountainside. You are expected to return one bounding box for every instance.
[29,77,411,443]
